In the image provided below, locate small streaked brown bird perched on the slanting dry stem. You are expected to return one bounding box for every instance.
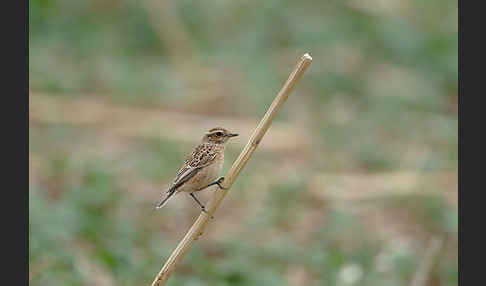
[156,127,238,212]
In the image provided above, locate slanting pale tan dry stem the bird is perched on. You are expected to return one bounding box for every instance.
[152,54,312,286]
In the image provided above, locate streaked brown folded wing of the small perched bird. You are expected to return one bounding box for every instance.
[167,144,216,193]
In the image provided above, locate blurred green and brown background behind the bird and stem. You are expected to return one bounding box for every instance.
[29,0,458,286]
